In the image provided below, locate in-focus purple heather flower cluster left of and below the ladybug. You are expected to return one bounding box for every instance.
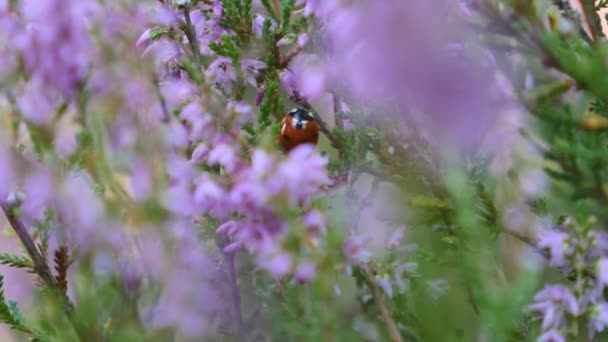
[138,1,329,282]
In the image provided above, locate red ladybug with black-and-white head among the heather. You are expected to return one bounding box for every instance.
[279,108,319,152]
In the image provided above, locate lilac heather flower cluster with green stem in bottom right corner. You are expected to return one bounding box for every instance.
[530,219,608,341]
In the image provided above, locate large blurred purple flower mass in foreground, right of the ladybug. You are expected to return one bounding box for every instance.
[324,0,508,152]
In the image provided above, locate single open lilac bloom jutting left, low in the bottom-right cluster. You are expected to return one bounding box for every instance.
[530,285,580,330]
